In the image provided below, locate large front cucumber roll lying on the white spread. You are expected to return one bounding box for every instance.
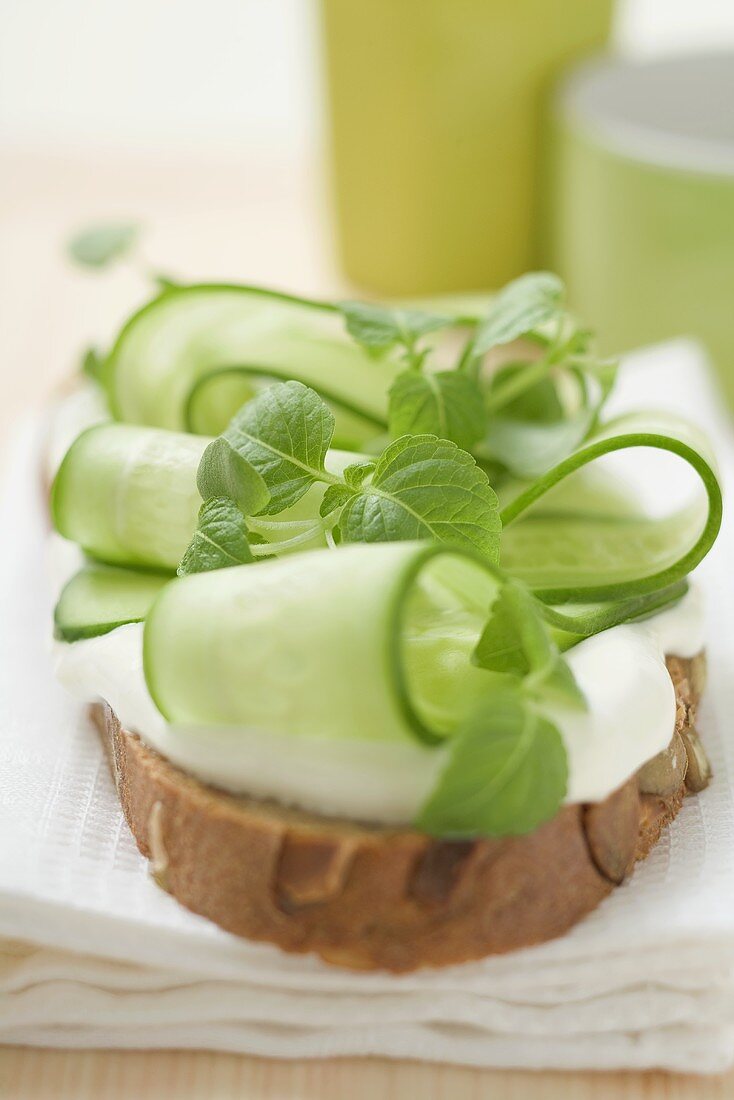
[143,542,499,743]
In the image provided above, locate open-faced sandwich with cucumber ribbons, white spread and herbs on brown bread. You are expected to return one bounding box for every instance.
[51,273,721,971]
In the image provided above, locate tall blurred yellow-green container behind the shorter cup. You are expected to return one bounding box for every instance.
[322,0,613,295]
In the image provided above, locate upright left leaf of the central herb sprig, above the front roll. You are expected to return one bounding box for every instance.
[202,382,333,516]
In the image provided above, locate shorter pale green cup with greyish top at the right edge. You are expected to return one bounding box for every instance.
[545,54,734,404]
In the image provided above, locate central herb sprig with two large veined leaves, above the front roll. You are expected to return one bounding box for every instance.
[198,382,500,561]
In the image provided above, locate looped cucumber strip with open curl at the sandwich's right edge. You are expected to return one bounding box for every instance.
[502,414,722,604]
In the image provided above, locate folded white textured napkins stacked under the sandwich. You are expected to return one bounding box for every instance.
[0,342,734,1071]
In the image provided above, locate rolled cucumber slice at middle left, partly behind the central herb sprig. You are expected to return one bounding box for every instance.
[52,424,363,572]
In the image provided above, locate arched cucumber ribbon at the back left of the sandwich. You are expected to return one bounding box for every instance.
[108,285,402,448]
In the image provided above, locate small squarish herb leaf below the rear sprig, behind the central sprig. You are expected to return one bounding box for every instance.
[388,371,485,450]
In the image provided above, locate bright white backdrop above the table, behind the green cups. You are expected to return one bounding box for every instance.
[0,0,734,154]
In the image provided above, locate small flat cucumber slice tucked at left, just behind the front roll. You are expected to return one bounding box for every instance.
[54,565,167,641]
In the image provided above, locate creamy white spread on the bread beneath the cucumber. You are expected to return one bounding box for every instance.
[56,589,703,825]
